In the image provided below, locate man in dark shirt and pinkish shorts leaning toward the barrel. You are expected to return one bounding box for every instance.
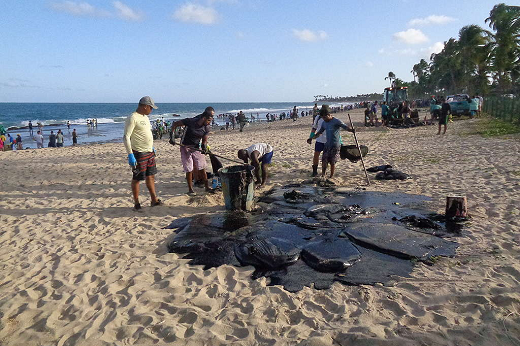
[170,107,213,195]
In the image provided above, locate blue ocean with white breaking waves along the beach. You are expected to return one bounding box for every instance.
[0,102,346,148]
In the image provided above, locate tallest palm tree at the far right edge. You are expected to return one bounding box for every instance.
[486,3,520,93]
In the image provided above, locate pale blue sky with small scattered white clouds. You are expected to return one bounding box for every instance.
[0,0,504,103]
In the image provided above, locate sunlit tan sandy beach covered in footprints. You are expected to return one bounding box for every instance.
[0,110,520,346]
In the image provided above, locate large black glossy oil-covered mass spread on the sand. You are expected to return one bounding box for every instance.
[168,181,460,292]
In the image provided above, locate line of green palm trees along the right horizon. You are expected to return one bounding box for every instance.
[406,3,520,98]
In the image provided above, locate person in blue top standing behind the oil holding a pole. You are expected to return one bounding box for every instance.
[307,105,355,178]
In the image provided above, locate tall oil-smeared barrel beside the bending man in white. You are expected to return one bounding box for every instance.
[218,165,255,211]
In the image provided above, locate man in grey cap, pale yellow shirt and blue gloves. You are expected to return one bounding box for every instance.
[123,96,162,210]
